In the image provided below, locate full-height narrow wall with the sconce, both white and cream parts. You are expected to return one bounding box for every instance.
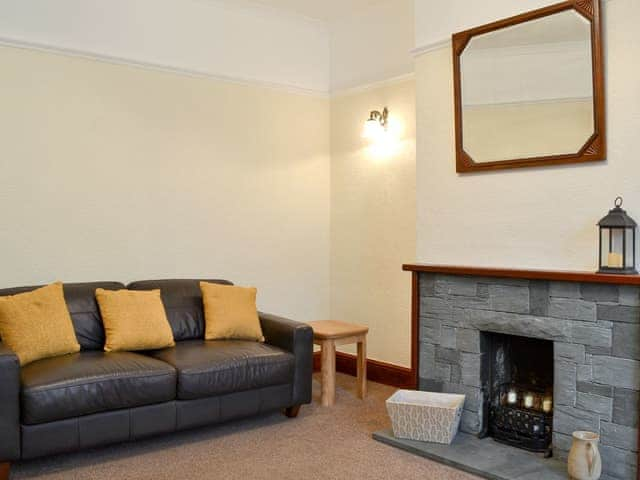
[329,0,416,366]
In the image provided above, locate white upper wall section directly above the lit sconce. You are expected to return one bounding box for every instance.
[329,0,414,92]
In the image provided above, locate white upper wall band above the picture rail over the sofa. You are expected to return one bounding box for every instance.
[0,0,329,93]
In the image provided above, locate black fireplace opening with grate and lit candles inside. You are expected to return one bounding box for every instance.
[480,332,553,457]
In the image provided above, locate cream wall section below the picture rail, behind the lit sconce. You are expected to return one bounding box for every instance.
[330,78,416,366]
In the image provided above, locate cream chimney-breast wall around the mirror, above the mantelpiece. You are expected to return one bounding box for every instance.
[416,0,640,271]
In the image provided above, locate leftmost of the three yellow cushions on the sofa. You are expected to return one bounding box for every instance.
[0,282,80,365]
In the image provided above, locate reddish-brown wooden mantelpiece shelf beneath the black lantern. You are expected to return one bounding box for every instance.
[402,263,640,285]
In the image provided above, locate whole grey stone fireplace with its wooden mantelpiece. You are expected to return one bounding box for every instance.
[408,266,640,480]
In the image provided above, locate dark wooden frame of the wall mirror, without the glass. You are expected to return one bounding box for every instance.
[452,0,606,173]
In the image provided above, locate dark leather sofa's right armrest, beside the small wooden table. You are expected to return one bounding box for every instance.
[259,312,313,406]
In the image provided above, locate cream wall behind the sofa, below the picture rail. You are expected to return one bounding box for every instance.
[0,47,330,320]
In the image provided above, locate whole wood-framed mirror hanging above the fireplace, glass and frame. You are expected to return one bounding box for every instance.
[453,0,605,172]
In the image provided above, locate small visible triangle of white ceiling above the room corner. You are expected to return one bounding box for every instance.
[239,0,385,22]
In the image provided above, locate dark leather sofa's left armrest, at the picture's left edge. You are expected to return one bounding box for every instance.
[0,342,20,462]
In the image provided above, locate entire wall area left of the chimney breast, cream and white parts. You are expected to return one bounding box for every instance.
[0,0,415,365]
